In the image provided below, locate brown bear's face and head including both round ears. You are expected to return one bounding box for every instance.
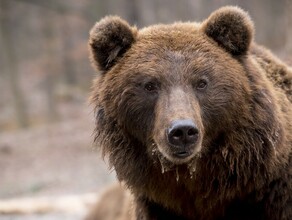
[90,7,252,164]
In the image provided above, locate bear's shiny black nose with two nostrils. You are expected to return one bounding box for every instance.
[167,119,199,152]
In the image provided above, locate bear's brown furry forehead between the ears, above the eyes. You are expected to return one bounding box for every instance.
[120,23,242,78]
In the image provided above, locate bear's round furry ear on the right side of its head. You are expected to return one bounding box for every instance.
[202,6,254,55]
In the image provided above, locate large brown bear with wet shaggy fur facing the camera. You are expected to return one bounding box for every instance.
[89,6,292,220]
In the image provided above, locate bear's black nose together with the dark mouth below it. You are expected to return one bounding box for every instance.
[166,119,199,158]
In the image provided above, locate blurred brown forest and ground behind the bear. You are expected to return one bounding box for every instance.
[0,0,292,219]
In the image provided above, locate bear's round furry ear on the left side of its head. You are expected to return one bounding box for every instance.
[89,16,137,71]
